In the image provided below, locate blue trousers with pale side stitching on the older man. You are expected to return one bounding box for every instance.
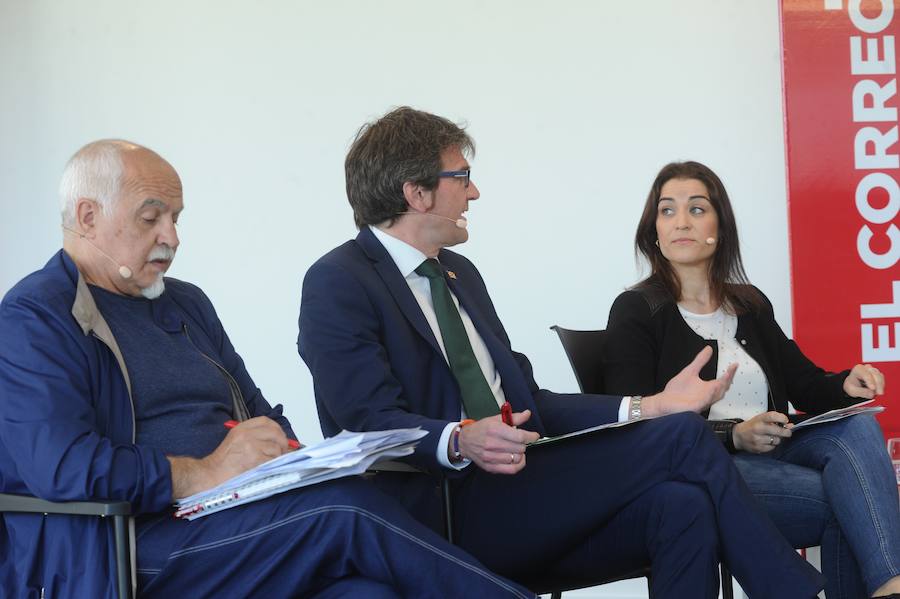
[137,478,534,599]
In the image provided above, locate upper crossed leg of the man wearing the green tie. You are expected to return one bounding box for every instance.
[455,414,824,599]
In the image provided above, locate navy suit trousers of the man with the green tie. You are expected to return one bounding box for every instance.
[454,414,824,599]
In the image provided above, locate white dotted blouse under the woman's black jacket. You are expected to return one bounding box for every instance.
[678,306,769,420]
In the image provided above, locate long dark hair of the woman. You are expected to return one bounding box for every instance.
[634,161,763,314]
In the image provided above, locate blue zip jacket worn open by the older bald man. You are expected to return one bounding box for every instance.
[0,251,289,598]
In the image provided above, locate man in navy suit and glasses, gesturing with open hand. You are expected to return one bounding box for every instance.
[298,107,823,599]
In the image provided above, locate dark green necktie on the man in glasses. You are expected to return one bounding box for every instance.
[416,258,500,420]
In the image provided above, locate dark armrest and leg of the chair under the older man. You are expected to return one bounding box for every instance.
[0,493,132,599]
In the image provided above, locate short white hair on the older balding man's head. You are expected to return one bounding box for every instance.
[59,139,139,227]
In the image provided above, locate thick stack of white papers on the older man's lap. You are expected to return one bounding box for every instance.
[175,428,428,520]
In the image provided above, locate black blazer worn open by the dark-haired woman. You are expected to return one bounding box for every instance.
[603,278,858,449]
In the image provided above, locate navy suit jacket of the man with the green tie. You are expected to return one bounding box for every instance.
[298,228,621,478]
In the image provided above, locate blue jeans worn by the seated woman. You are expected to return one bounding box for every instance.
[735,415,900,599]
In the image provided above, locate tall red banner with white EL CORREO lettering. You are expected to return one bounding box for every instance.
[781,0,900,437]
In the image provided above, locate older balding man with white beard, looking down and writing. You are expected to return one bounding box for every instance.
[0,140,533,599]
